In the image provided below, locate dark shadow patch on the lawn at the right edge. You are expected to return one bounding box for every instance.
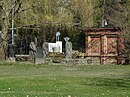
[82,75,130,89]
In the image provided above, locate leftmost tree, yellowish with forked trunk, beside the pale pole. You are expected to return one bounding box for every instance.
[0,0,34,58]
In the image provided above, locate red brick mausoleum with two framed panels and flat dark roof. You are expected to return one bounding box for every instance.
[85,28,124,64]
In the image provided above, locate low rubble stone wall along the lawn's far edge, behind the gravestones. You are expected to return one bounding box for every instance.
[15,55,100,65]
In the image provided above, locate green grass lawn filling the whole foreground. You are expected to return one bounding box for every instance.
[0,63,130,97]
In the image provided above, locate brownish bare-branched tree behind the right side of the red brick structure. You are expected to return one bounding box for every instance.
[104,0,130,57]
